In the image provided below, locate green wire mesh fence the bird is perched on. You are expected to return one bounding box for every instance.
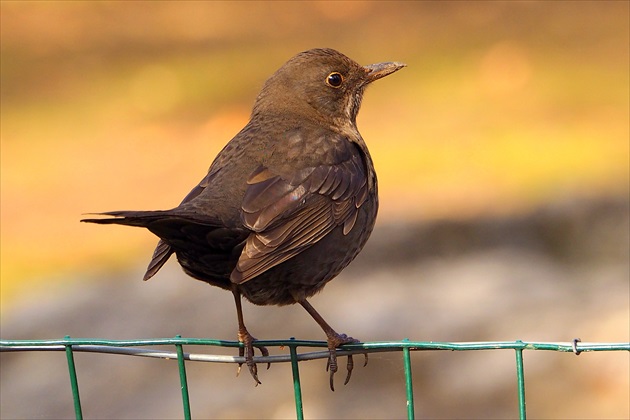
[0,336,630,419]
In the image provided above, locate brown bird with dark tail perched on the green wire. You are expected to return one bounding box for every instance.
[82,49,405,390]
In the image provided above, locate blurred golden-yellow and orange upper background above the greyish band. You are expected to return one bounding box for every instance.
[1,1,629,307]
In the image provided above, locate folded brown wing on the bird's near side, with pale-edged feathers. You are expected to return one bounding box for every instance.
[231,146,368,283]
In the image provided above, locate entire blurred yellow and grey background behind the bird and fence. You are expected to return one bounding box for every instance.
[0,1,630,418]
